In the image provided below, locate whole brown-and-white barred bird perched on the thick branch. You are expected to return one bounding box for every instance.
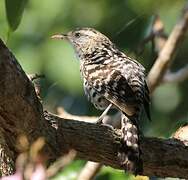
[52,28,150,174]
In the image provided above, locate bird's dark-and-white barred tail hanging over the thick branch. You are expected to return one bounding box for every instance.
[119,113,142,175]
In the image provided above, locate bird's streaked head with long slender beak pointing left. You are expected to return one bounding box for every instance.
[52,28,111,59]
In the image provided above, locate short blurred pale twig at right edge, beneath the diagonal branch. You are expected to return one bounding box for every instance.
[162,64,188,83]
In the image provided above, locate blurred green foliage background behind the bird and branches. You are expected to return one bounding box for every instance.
[0,0,188,180]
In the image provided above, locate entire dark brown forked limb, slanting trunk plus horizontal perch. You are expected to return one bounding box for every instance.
[0,38,188,178]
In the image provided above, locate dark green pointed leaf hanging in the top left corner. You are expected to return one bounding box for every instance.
[5,0,28,31]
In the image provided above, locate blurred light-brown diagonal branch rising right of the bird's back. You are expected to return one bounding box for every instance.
[148,4,188,92]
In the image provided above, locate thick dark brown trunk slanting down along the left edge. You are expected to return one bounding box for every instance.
[0,40,63,176]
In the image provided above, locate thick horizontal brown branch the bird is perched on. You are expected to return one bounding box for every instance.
[46,114,188,178]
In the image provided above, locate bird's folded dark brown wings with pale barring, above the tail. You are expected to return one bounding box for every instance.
[103,71,151,120]
